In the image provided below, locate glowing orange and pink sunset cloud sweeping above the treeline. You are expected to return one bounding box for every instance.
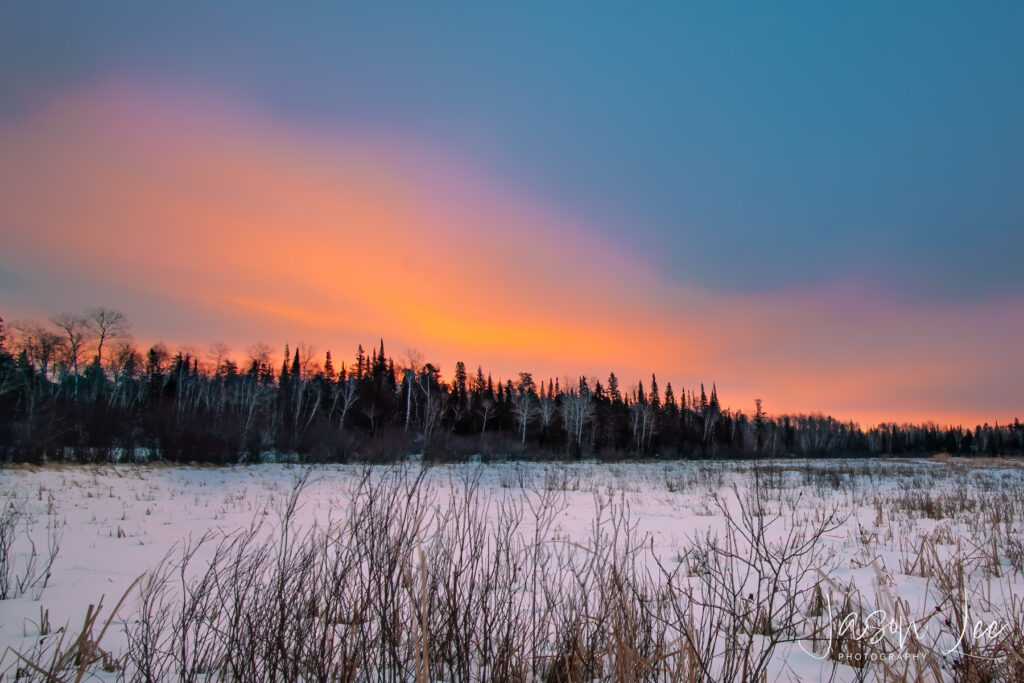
[0,84,1022,422]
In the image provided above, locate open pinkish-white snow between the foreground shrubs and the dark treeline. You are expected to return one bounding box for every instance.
[0,461,1024,681]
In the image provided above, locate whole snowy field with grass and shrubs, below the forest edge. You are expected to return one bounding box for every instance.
[0,460,1024,681]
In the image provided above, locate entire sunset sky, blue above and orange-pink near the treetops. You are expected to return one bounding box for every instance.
[0,1,1024,425]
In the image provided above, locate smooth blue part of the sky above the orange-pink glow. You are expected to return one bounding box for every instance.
[0,2,1024,421]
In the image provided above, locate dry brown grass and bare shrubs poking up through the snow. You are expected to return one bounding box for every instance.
[2,462,1024,683]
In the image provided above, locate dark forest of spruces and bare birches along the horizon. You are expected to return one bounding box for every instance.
[0,308,1024,464]
